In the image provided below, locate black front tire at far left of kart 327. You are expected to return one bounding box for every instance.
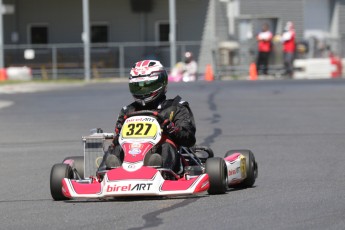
[50,163,73,200]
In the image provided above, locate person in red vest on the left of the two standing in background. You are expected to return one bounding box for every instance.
[256,23,273,75]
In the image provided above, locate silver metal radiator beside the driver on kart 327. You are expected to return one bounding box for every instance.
[83,135,105,178]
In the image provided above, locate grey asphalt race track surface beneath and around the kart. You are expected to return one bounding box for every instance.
[0,80,345,230]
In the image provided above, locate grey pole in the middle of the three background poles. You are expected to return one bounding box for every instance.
[82,0,91,81]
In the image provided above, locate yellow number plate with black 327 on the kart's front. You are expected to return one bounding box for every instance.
[121,122,157,138]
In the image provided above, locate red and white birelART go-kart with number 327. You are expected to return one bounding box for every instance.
[50,110,258,200]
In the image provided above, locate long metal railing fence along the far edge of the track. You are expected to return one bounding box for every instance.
[4,37,345,79]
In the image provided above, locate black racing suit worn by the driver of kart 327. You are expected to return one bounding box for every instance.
[101,95,196,172]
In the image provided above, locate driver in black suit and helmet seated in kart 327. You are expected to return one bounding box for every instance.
[99,60,196,172]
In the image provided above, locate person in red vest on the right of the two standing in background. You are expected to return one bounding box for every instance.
[281,21,295,78]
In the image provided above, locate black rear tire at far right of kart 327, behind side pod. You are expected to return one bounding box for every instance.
[225,150,258,188]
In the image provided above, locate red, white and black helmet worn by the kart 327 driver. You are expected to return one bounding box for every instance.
[129,60,168,106]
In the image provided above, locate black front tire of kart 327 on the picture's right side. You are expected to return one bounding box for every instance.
[206,157,228,195]
